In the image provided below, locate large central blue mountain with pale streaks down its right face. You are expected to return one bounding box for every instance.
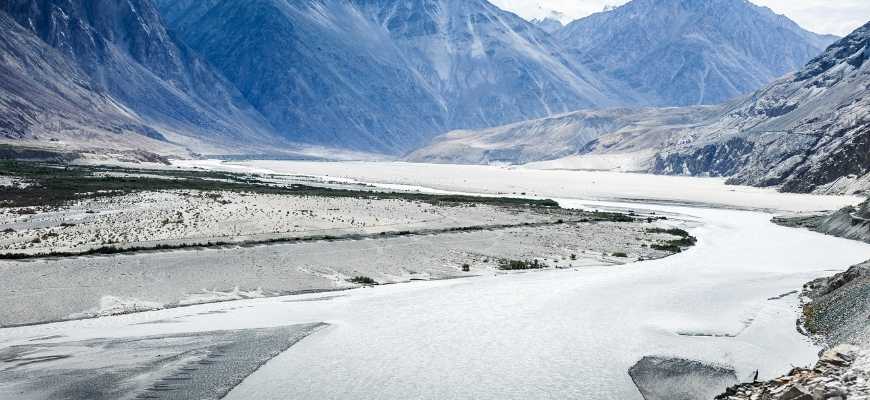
[158,0,635,153]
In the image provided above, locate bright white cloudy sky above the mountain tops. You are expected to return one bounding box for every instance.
[490,0,870,36]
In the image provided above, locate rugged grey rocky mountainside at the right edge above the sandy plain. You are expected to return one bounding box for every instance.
[653,23,870,193]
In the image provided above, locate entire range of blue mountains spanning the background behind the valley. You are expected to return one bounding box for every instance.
[0,0,833,155]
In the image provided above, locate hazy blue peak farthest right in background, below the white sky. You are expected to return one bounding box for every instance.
[555,0,836,106]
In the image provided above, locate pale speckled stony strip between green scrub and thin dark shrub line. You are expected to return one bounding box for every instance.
[0,190,569,254]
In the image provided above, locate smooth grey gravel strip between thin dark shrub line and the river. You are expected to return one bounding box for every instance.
[0,217,688,326]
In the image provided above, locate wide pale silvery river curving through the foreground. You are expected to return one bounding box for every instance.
[0,163,870,400]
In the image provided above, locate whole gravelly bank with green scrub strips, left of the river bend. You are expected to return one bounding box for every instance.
[0,164,695,326]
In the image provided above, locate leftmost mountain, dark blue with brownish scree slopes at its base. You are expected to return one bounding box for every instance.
[0,0,281,152]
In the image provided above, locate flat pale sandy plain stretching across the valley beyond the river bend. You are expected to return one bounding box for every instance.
[186,160,864,212]
